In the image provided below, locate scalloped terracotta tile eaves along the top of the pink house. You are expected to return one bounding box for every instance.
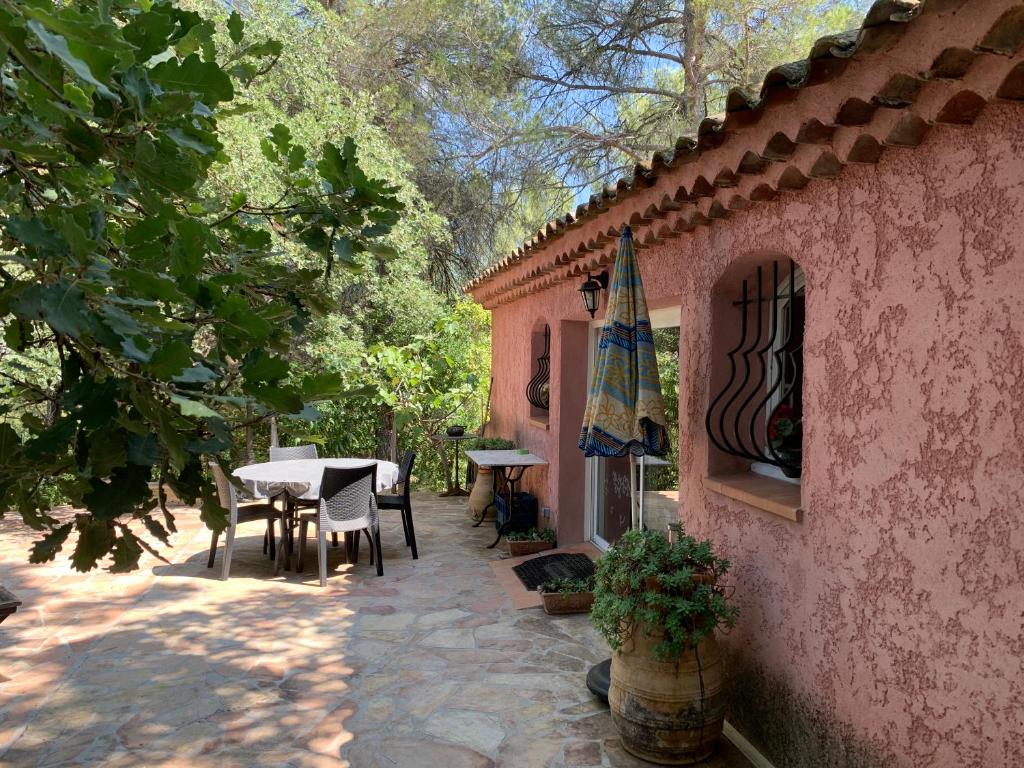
[466,0,1024,302]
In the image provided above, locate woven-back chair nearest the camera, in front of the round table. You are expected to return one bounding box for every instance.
[297,462,384,587]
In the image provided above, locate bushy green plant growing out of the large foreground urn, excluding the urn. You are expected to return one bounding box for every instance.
[591,530,739,660]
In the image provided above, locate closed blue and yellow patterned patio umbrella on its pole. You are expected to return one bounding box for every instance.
[580,226,669,527]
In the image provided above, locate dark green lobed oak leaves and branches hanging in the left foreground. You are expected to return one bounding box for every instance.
[0,0,402,570]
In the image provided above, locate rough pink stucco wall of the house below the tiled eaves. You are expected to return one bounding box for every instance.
[479,102,1024,768]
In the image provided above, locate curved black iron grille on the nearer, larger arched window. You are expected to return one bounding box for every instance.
[705,260,804,477]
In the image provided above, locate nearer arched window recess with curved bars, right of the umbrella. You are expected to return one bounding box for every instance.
[705,258,805,479]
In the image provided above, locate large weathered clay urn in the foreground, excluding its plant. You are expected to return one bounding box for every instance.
[608,631,725,765]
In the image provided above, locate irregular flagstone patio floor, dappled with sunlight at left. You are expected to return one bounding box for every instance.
[0,495,746,768]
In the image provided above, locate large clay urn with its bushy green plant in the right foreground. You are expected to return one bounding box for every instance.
[591,530,738,765]
